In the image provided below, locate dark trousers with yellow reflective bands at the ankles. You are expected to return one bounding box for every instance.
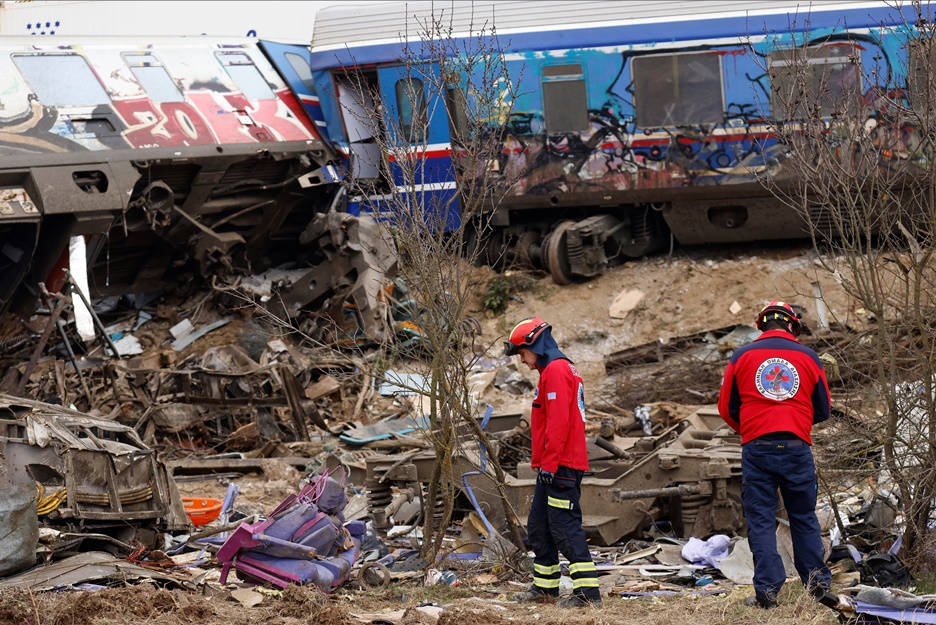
[527,466,601,601]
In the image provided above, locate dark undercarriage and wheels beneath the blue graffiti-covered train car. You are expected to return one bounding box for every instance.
[478,178,822,285]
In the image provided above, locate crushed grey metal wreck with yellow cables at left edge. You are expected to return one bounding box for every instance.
[0,395,190,530]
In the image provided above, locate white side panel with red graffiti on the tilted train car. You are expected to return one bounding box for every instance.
[0,40,318,152]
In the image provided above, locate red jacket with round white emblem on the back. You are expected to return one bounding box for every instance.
[718,330,830,445]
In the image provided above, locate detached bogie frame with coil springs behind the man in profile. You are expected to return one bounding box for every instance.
[365,408,745,545]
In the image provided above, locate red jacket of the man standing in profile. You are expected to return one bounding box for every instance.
[530,358,588,473]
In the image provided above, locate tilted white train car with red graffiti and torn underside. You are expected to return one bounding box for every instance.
[0,37,348,312]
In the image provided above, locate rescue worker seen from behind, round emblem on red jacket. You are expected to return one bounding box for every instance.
[718,301,832,608]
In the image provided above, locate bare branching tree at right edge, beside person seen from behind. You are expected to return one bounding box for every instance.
[752,2,936,571]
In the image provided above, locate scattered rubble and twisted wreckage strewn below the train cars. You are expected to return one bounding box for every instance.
[0,245,931,623]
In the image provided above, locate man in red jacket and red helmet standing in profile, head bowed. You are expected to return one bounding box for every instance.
[504,317,601,607]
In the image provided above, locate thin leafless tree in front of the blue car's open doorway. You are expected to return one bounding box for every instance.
[326,4,520,557]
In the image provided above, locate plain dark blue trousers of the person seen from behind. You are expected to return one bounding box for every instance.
[741,441,832,599]
